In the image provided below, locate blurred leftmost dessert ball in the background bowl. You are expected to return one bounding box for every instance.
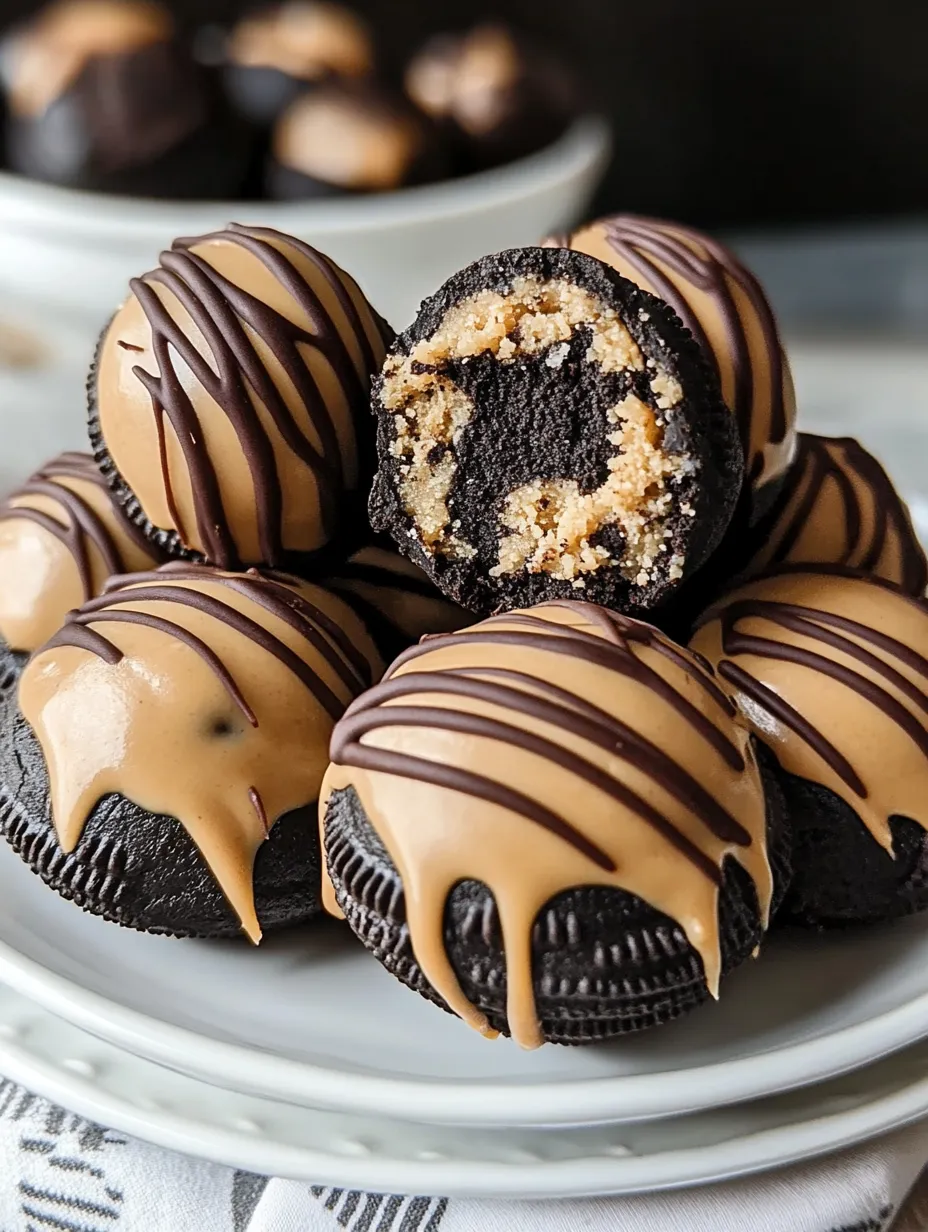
[4,0,245,198]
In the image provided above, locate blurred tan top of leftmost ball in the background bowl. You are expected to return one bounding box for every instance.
[4,0,174,116]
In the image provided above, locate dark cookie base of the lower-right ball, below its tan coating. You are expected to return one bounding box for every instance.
[780,772,928,928]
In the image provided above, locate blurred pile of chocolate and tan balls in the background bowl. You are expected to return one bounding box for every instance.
[2,0,577,200]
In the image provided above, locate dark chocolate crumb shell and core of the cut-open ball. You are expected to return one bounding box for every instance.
[368,249,743,615]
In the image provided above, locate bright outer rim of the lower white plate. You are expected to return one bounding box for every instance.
[0,970,928,1200]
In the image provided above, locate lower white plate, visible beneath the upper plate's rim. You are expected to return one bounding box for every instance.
[0,970,928,1199]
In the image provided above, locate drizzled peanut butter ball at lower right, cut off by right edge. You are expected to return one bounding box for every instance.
[690,567,928,926]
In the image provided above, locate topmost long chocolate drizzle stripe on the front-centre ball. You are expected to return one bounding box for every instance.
[396,612,744,770]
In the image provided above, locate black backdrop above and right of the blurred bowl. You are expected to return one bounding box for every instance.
[0,0,928,227]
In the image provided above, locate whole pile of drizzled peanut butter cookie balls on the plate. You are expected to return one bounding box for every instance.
[0,209,928,1047]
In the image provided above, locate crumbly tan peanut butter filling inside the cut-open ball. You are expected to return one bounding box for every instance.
[382,278,695,589]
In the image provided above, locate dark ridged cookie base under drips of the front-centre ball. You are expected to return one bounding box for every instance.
[325,750,791,1044]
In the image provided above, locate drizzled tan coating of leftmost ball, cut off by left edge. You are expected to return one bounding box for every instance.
[0,453,160,650]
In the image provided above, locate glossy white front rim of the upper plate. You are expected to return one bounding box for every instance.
[0,921,928,1127]
